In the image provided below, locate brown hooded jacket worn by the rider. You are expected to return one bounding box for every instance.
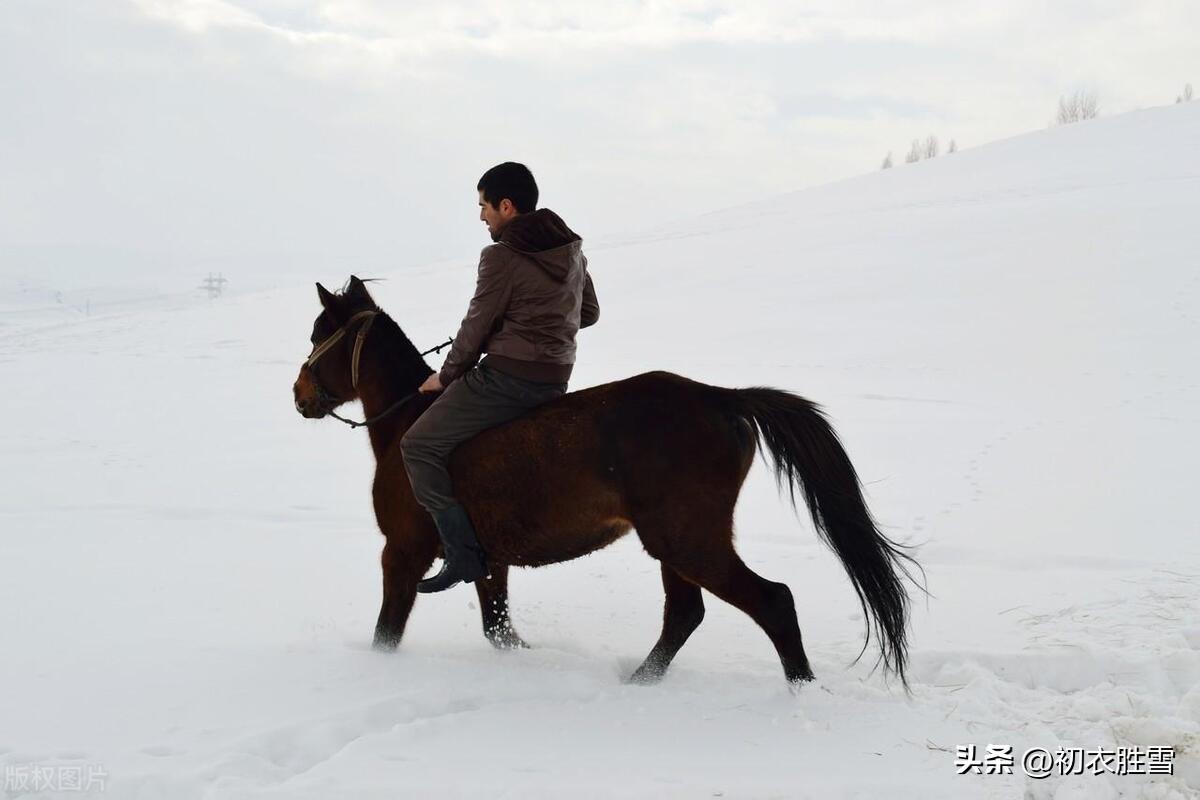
[440,209,600,385]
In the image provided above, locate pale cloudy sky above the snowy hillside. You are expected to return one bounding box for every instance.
[0,0,1200,287]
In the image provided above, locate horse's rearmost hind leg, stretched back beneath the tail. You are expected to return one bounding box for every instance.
[638,522,812,684]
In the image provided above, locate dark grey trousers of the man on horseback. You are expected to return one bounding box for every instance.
[400,365,566,515]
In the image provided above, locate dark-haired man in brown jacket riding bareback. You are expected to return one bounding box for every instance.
[400,162,600,593]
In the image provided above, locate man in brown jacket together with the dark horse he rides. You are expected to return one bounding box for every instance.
[292,181,923,685]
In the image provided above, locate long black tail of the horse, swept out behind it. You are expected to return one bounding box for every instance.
[731,386,924,686]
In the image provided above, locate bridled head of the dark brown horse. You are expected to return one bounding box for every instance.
[292,275,379,420]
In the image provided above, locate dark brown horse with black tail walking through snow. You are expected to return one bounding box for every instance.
[294,277,916,682]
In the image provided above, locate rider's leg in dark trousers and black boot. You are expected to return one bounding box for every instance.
[400,367,566,591]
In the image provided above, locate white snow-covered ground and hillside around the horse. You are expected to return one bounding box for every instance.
[7,103,1200,800]
